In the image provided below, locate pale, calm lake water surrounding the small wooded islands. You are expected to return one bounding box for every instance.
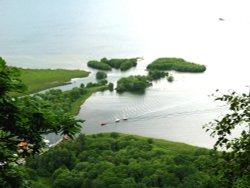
[0,0,250,147]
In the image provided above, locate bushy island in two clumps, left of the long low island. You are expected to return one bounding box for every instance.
[88,58,138,71]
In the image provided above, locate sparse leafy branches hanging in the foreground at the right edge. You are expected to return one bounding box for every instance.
[205,92,250,187]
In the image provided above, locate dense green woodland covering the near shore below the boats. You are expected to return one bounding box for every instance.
[27,133,222,188]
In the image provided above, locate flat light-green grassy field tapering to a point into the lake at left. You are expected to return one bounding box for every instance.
[19,69,89,94]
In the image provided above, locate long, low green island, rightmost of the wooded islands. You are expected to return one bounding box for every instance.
[147,58,206,72]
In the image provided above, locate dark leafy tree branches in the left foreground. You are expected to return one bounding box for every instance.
[0,58,82,187]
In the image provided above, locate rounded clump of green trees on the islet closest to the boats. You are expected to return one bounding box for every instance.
[116,76,151,93]
